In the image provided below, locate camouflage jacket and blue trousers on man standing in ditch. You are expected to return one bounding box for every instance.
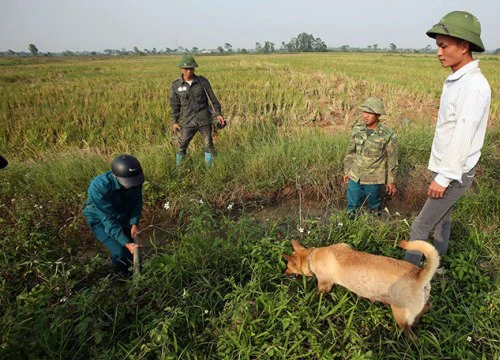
[344,123,398,210]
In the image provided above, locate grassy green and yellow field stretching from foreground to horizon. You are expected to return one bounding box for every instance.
[0,53,500,359]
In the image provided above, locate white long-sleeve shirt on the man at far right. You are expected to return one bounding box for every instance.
[428,60,491,187]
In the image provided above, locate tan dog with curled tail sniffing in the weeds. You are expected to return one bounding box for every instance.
[283,240,439,340]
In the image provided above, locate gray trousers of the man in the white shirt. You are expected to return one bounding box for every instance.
[405,168,475,266]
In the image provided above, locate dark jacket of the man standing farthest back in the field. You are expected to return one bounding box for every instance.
[170,75,221,127]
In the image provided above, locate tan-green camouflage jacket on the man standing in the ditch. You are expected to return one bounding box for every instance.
[344,123,398,184]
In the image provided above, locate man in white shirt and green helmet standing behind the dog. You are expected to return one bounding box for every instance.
[405,11,491,265]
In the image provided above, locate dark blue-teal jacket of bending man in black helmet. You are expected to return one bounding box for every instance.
[83,171,142,245]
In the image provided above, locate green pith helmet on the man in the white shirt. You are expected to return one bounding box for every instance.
[426,11,484,52]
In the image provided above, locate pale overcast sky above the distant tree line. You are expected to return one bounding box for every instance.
[0,0,500,52]
